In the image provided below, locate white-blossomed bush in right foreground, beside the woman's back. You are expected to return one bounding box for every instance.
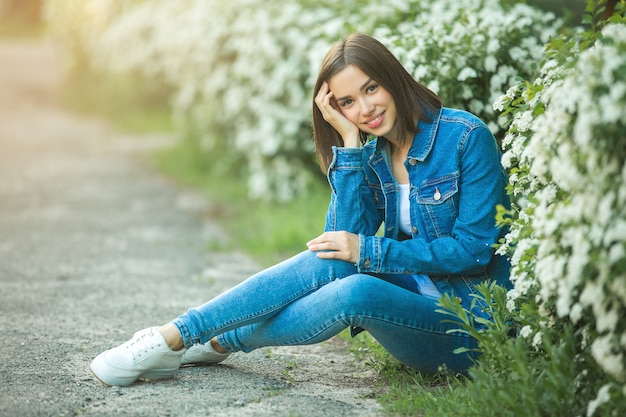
[499,24,626,406]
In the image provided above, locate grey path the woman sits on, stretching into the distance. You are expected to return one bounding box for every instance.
[0,41,381,417]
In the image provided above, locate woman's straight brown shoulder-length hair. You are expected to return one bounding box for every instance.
[313,33,441,172]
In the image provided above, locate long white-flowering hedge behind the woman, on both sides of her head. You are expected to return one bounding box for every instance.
[48,0,554,200]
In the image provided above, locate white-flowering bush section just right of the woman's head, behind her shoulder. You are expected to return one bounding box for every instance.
[377,0,561,135]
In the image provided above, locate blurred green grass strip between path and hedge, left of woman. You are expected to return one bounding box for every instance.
[153,140,330,266]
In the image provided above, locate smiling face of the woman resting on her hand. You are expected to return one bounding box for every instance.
[328,65,398,141]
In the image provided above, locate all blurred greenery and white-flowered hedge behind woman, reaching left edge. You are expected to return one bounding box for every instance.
[0,0,584,202]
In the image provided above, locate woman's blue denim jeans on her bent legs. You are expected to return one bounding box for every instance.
[173,251,476,373]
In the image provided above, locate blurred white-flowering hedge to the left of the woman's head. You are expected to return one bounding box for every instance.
[56,0,424,200]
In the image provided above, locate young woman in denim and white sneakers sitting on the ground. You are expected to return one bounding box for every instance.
[91,34,509,385]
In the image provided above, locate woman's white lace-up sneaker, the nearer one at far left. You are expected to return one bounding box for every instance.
[90,327,185,386]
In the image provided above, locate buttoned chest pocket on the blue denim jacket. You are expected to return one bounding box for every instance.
[417,172,459,238]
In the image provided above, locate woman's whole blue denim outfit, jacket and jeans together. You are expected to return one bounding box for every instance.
[173,109,509,373]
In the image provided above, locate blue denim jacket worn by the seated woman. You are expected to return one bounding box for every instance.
[325,108,510,316]
